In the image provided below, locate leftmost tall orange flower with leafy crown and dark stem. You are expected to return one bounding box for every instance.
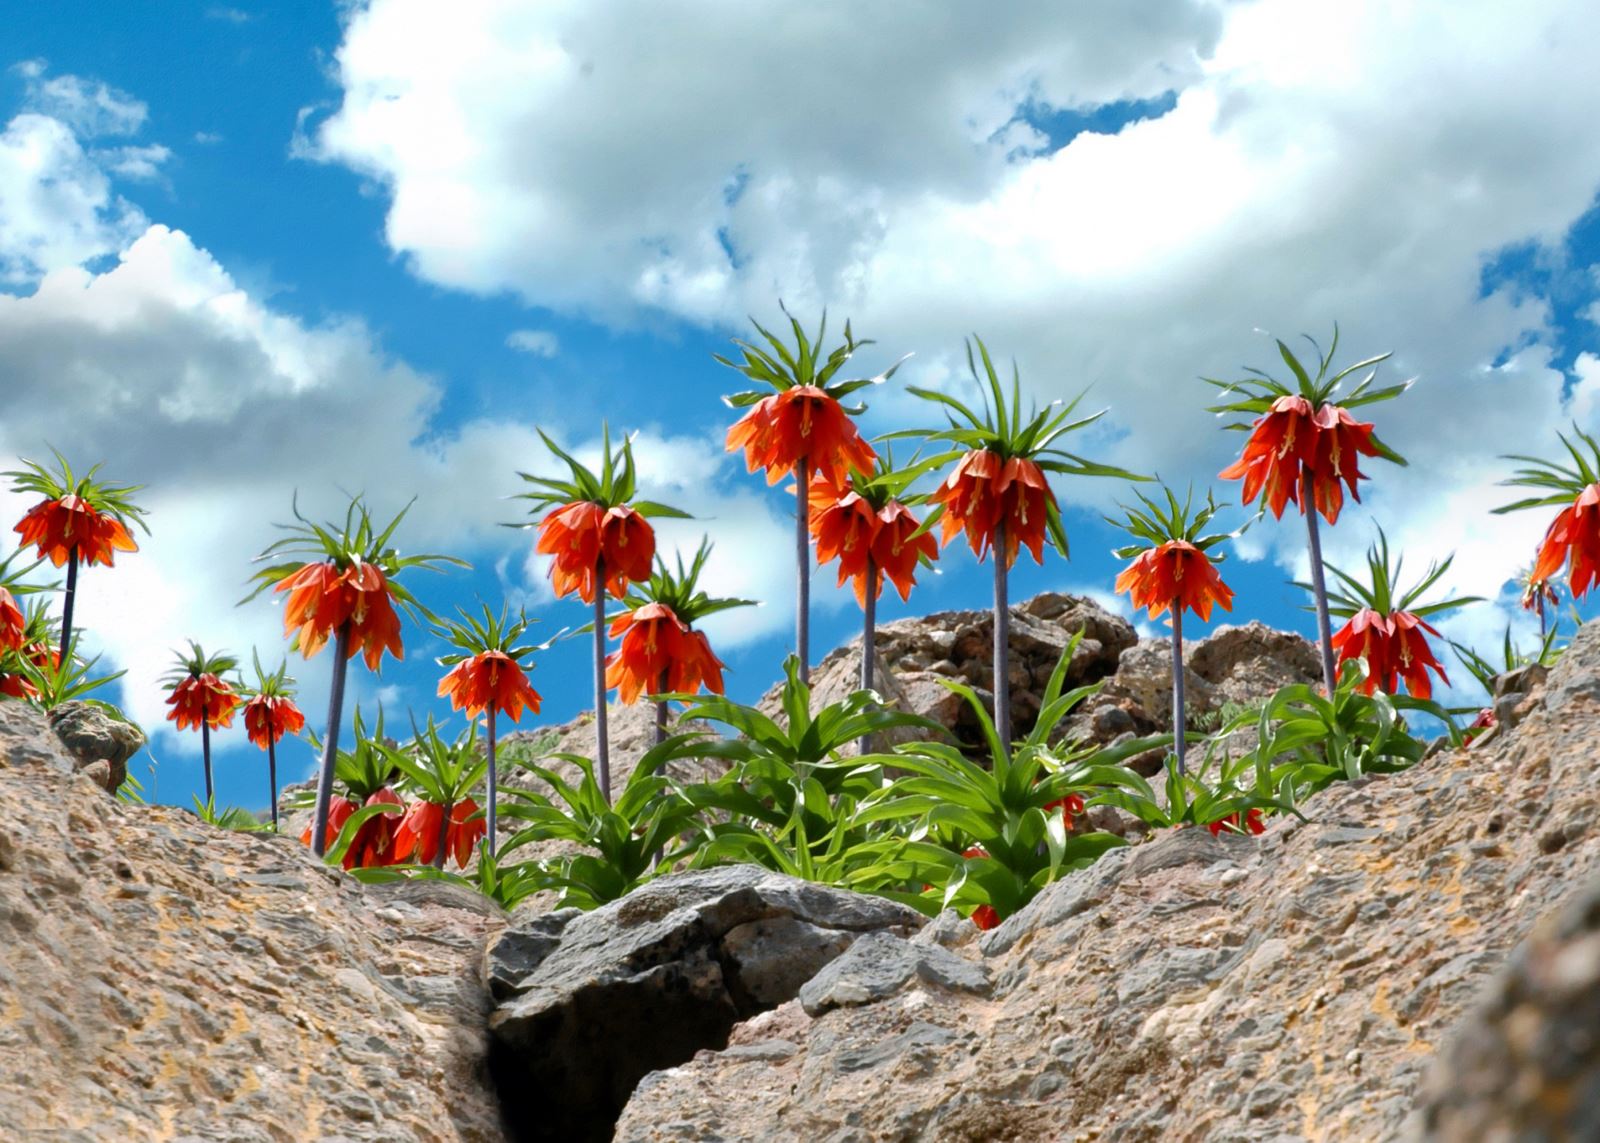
[0,450,150,647]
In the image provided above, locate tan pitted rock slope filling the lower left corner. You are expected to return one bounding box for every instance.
[0,701,504,1143]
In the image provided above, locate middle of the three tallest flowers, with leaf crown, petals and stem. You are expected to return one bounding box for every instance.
[908,335,1149,749]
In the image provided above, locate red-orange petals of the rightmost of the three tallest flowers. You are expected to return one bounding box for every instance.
[1219,394,1379,523]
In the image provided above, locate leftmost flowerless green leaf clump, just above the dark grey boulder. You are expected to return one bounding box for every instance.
[496,735,699,909]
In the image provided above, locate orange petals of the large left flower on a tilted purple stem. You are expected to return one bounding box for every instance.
[274,562,405,671]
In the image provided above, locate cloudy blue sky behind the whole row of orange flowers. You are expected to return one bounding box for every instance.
[0,0,1600,805]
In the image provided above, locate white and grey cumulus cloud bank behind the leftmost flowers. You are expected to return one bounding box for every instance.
[0,78,782,749]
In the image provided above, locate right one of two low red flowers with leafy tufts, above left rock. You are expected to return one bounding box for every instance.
[384,716,494,869]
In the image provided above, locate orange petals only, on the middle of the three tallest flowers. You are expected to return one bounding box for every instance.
[928,448,1056,568]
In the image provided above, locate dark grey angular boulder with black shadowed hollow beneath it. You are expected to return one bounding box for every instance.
[488,866,928,1143]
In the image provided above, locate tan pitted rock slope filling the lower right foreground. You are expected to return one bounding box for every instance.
[616,624,1600,1143]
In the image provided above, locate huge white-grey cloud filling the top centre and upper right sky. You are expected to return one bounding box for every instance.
[309,0,1600,630]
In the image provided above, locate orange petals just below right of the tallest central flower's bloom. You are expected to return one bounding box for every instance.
[810,477,939,607]
